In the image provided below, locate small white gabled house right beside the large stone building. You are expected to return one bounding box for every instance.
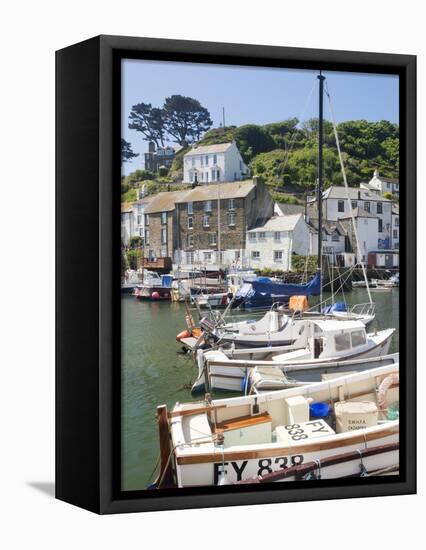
[246,214,311,271]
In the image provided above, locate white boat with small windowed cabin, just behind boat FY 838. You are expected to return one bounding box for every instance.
[192,320,395,395]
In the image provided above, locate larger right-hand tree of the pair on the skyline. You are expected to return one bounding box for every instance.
[163,95,213,147]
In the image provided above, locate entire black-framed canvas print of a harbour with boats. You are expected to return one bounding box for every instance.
[56,36,416,513]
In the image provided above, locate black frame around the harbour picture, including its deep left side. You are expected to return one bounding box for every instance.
[56,36,416,514]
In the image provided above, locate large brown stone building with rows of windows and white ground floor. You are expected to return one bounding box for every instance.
[174,178,274,267]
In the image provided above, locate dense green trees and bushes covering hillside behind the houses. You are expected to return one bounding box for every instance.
[198,118,399,192]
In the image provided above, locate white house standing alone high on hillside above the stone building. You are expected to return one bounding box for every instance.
[183,141,249,184]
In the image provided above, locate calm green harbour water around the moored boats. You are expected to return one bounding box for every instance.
[122,289,399,490]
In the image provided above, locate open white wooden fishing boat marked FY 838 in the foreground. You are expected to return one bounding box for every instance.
[156,365,399,488]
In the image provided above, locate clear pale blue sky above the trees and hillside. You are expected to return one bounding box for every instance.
[122,59,399,174]
